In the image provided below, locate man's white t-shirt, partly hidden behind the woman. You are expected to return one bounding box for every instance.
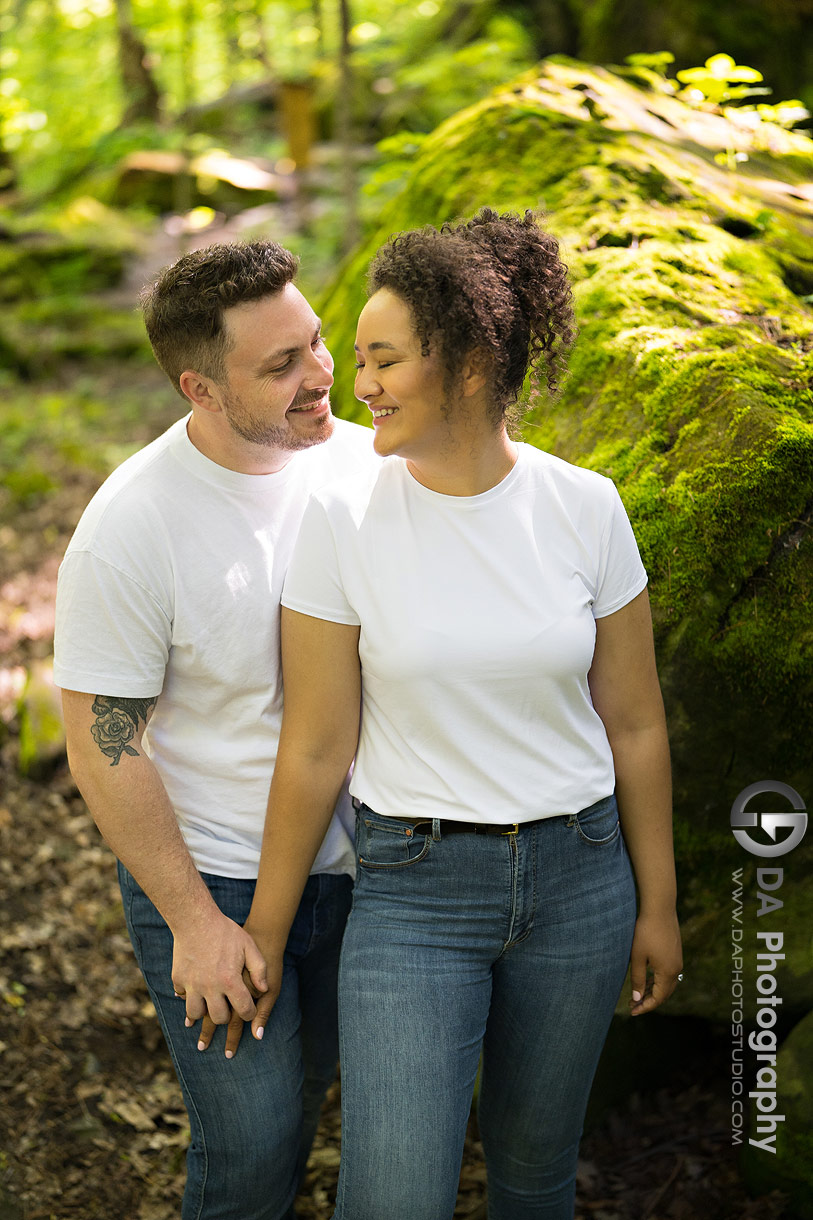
[54,420,380,877]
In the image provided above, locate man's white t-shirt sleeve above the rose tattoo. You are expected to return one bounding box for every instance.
[54,550,172,699]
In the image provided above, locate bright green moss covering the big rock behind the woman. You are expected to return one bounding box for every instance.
[314,63,813,732]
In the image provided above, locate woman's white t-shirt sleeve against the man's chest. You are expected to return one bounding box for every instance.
[282,497,361,627]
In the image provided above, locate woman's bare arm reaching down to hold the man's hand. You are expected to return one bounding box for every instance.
[199,606,361,1058]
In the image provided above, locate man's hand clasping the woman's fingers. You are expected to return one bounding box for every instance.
[172,911,268,1025]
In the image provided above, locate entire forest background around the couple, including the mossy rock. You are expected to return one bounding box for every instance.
[0,0,813,1220]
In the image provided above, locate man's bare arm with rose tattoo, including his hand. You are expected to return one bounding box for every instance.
[62,691,266,1024]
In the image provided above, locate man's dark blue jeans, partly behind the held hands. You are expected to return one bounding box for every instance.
[118,864,352,1220]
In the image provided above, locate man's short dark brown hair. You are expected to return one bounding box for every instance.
[139,242,299,398]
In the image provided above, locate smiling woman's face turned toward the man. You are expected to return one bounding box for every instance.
[355,288,461,465]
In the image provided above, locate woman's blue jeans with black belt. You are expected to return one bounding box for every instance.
[334,797,636,1220]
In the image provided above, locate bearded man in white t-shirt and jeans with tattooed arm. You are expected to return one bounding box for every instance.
[55,242,376,1220]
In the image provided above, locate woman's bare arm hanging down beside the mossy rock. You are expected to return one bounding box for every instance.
[588,589,682,1016]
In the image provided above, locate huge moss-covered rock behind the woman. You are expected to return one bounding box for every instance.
[322,61,813,1020]
